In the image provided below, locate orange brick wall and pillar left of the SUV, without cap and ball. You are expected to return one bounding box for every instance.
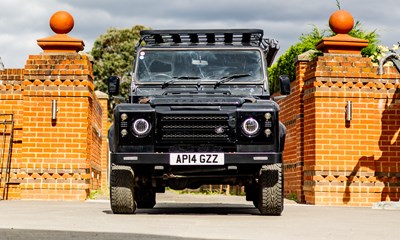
[0,53,107,200]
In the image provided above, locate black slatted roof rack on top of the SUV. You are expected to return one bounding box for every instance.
[137,29,279,65]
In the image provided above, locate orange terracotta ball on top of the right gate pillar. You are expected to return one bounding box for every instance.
[329,10,354,34]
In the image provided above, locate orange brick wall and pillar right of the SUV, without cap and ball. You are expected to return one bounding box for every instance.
[281,54,400,206]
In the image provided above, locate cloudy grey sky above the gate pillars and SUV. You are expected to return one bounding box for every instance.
[0,0,400,68]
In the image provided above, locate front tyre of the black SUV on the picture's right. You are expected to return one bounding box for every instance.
[257,163,283,215]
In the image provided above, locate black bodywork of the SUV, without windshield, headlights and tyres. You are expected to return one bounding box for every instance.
[109,29,290,189]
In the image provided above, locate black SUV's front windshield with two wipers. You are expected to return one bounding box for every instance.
[136,49,264,84]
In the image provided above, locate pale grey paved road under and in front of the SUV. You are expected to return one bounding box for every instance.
[0,193,400,240]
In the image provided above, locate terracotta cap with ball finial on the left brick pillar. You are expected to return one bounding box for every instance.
[37,11,85,53]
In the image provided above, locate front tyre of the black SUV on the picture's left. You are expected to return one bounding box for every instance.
[110,165,136,214]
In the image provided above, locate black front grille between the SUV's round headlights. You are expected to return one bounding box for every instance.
[157,113,235,143]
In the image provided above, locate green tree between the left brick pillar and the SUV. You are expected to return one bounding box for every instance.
[91,25,148,96]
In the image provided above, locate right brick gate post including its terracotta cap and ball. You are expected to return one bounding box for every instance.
[303,10,400,206]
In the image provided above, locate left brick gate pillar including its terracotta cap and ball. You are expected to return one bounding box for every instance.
[16,12,102,200]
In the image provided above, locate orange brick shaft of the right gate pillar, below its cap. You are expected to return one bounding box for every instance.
[304,54,386,205]
